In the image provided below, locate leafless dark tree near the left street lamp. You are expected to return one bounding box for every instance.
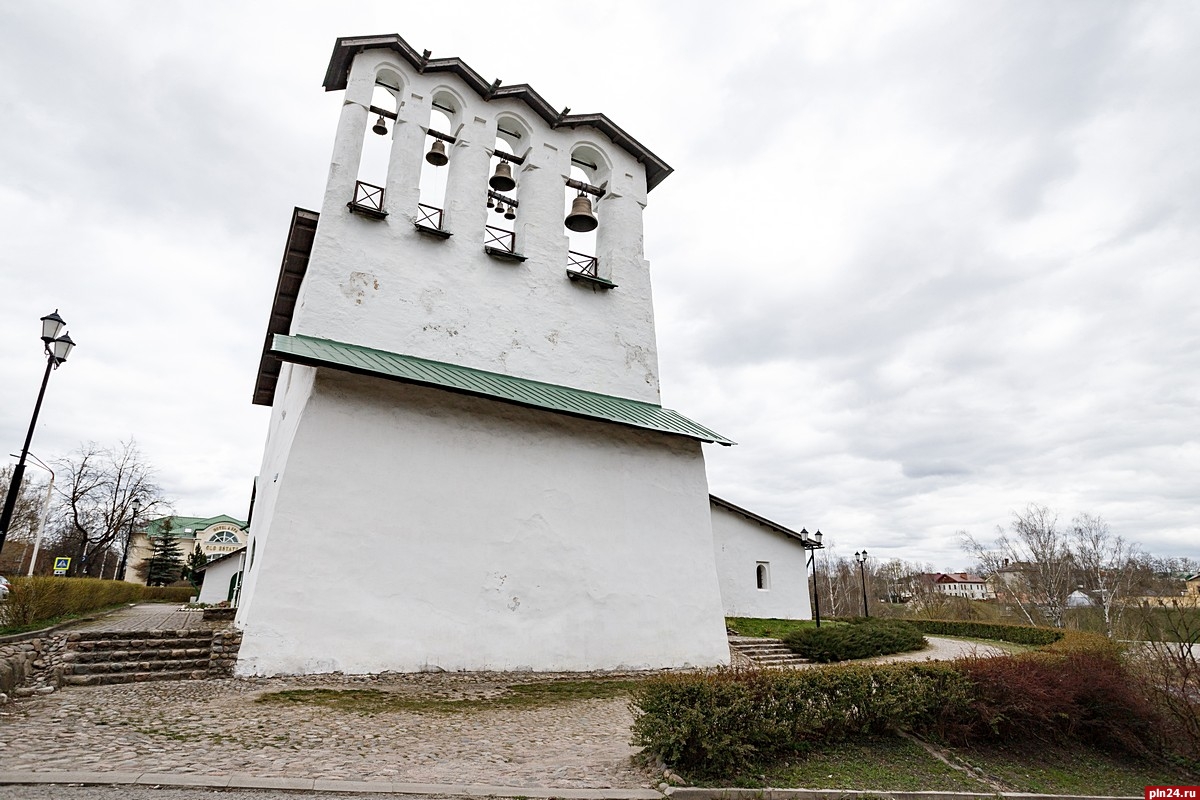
[56,440,167,577]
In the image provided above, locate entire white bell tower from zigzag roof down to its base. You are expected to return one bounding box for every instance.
[236,35,732,675]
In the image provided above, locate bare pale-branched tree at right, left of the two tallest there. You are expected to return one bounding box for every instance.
[962,504,1075,627]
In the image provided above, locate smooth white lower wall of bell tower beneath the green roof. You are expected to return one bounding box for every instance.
[229,369,728,675]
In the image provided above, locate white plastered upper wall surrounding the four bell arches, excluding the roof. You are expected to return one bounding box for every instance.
[292,50,659,403]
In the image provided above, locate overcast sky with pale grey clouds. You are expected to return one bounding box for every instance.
[0,0,1200,569]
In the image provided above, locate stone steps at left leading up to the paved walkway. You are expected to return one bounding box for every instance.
[61,628,240,686]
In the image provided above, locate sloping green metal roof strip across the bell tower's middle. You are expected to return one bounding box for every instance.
[271,333,736,445]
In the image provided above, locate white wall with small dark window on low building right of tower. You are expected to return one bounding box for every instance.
[712,503,812,619]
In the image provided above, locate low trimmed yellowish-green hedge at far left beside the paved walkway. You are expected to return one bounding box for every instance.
[0,577,194,633]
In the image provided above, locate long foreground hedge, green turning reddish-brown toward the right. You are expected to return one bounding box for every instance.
[632,640,1178,778]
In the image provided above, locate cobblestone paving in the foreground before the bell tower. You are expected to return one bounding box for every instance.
[0,673,652,788]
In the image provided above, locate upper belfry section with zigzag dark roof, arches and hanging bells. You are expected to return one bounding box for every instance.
[285,37,671,403]
